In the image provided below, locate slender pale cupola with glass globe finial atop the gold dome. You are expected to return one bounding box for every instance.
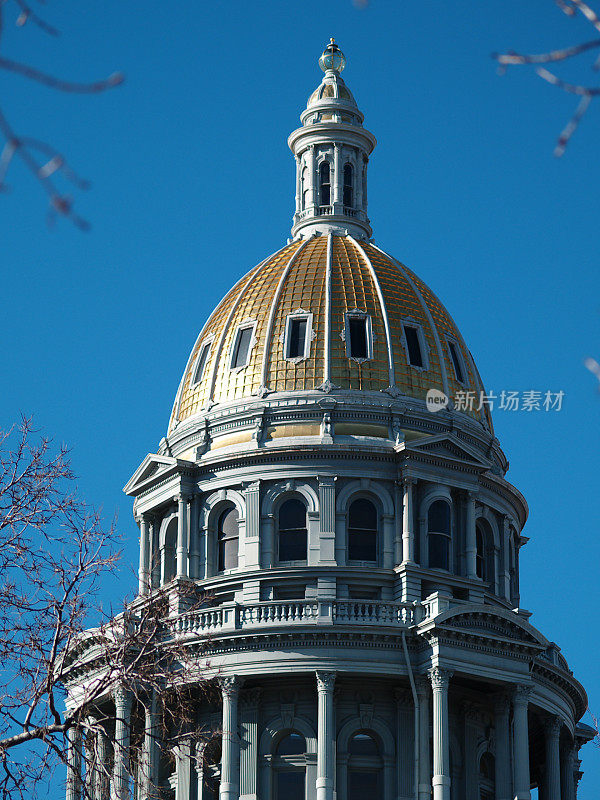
[288,39,377,239]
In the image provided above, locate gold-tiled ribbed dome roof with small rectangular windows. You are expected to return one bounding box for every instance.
[169,233,491,431]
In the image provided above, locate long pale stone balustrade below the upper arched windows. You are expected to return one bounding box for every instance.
[170,600,423,636]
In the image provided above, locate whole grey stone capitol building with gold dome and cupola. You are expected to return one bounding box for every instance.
[67,40,592,800]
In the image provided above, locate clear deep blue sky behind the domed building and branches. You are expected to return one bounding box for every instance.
[0,0,600,800]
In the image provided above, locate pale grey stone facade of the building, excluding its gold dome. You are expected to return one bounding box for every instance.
[63,39,590,800]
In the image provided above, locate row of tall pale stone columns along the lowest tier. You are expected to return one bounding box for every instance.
[66,666,579,800]
